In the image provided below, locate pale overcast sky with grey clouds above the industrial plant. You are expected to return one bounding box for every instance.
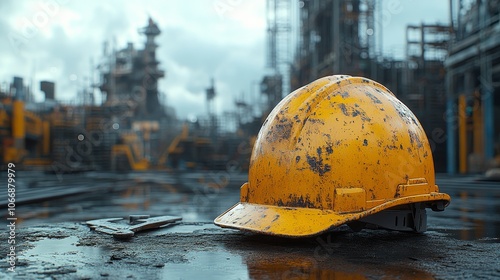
[0,0,449,118]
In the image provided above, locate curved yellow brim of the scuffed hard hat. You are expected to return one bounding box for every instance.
[214,192,450,237]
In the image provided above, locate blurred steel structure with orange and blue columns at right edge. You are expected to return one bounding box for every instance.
[445,0,500,174]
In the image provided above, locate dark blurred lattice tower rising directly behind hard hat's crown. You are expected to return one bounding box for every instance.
[291,0,377,89]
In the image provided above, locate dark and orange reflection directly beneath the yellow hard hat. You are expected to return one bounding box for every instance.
[225,230,442,279]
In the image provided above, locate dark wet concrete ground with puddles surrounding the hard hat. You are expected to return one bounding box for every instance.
[0,171,500,279]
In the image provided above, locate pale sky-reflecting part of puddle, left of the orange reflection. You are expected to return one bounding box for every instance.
[162,251,249,280]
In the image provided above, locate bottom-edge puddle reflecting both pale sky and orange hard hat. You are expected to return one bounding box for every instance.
[164,251,433,280]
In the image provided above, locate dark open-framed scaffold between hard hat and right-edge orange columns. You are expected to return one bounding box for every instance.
[398,23,451,172]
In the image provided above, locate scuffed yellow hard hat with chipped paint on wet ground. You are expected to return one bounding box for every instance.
[214,76,450,237]
